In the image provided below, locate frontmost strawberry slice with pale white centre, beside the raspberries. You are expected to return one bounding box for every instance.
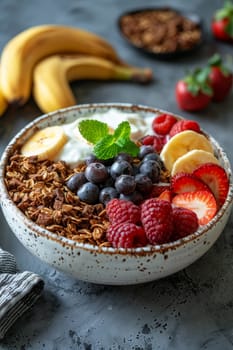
[172,191,217,225]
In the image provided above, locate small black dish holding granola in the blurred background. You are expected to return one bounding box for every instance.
[118,7,204,59]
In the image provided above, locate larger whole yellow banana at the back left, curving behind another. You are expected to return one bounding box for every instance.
[0,25,125,105]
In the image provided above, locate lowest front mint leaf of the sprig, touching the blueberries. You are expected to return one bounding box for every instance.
[93,135,121,160]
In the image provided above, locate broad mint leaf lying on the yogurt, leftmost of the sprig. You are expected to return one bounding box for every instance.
[78,119,109,144]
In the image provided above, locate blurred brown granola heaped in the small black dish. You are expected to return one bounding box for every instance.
[120,9,201,53]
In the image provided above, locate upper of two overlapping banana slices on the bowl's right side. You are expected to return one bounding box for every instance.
[160,130,214,171]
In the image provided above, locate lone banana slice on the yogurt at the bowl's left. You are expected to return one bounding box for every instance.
[21,126,67,160]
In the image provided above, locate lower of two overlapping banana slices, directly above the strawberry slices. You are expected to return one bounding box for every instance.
[171,149,219,176]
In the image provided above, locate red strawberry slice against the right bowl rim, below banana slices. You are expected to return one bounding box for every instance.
[193,163,229,207]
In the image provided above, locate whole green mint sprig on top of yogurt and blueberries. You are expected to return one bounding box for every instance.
[78,119,139,160]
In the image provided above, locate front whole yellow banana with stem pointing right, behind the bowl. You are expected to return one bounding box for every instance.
[33,55,152,113]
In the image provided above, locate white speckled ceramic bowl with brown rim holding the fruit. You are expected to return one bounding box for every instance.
[0,103,233,285]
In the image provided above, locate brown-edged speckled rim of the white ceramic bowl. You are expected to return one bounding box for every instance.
[0,103,233,255]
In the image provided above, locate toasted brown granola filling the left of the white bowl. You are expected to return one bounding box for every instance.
[5,152,110,246]
